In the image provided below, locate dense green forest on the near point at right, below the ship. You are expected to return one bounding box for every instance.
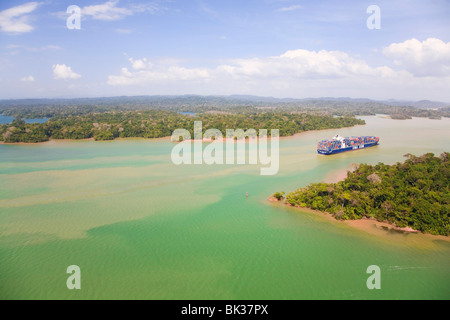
[282,152,450,236]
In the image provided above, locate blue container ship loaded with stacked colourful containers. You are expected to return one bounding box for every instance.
[317,135,380,155]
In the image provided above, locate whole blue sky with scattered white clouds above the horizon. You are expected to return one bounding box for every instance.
[0,0,450,102]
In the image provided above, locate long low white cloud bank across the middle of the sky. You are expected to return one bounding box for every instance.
[107,50,394,86]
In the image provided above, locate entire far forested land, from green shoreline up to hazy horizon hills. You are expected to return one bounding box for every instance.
[0,95,450,143]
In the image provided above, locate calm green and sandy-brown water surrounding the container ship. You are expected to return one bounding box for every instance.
[0,117,450,299]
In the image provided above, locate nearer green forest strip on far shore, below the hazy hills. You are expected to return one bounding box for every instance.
[0,107,365,143]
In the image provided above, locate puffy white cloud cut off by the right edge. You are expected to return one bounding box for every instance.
[383,38,450,77]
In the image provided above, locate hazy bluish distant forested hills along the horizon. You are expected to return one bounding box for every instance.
[0,95,450,119]
